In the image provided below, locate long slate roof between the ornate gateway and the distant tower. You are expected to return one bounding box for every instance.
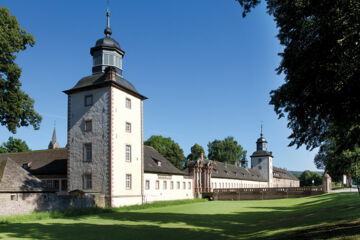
[186,159,267,182]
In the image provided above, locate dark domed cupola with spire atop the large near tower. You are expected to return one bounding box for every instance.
[90,9,125,76]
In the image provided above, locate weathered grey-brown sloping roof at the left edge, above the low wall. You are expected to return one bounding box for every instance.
[0,157,52,192]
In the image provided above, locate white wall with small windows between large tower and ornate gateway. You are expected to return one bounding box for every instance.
[144,173,194,202]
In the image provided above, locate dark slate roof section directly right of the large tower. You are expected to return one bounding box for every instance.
[144,145,185,175]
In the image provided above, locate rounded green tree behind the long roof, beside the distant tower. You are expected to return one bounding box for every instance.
[208,137,246,165]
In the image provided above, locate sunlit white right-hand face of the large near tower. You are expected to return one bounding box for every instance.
[111,87,143,207]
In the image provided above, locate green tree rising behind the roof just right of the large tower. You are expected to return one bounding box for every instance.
[144,136,185,169]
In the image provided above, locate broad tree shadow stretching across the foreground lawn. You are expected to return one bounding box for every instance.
[0,193,360,240]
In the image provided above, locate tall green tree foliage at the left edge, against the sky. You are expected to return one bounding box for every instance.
[0,7,41,133]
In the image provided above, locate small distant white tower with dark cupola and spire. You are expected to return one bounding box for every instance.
[250,126,273,187]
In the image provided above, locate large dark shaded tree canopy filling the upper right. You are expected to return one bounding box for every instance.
[237,0,360,180]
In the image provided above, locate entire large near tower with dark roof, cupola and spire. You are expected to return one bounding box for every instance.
[64,10,146,207]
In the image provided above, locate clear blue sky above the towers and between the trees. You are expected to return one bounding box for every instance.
[0,0,317,171]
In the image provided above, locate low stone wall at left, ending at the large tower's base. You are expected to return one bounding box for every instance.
[0,193,98,216]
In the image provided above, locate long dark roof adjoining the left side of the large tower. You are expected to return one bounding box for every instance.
[0,148,67,175]
